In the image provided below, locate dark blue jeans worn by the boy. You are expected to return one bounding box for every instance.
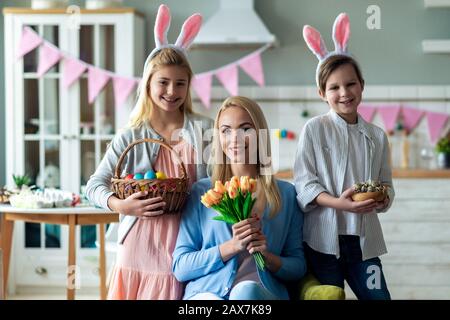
[304,236,391,300]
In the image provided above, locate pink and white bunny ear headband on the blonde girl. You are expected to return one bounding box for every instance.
[145,4,202,66]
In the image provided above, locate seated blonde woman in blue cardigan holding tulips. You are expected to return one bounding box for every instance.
[173,97,306,300]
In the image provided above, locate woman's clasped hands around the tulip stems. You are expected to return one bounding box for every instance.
[231,217,261,253]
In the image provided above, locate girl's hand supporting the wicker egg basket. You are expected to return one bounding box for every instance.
[108,191,166,219]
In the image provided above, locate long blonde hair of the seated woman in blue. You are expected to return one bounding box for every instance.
[209,96,281,217]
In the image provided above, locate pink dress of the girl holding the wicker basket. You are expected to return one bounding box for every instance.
[108,140,196,300]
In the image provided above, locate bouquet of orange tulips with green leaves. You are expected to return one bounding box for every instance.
[201,176,265,271]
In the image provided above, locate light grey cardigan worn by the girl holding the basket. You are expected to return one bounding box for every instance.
[86,114,213,243]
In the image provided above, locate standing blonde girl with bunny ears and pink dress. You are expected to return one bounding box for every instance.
[86,6,212,299]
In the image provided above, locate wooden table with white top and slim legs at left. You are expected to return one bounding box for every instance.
[0,205,119,300]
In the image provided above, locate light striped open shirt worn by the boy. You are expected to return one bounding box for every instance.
[294,109,395,260]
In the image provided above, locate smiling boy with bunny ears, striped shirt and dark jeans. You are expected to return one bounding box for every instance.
[294,14,394,299]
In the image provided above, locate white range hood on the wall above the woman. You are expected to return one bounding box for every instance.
[192,0,276,48]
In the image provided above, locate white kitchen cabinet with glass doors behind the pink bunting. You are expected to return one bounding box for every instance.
[3,8,145,288]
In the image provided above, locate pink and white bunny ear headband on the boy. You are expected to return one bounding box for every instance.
[303,13,350,86]
